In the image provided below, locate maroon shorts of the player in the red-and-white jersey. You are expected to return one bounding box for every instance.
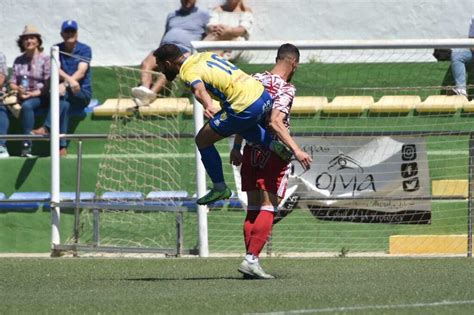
[240,145,290,198]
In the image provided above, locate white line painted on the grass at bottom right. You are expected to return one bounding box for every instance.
[248,300,474,315]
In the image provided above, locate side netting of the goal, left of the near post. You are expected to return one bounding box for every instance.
[61,66,198,254]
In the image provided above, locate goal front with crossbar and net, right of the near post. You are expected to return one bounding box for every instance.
[196,41,474,255]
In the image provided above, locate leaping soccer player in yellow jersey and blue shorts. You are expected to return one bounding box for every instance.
[154,44,292,205]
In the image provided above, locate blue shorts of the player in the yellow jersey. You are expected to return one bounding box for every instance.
[209,91,273,137]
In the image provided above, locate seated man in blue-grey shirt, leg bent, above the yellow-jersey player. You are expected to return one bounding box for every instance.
[132,0,209,106]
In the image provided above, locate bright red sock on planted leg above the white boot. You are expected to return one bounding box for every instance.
[247,210,275,257]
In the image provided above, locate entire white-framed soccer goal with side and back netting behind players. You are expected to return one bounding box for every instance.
[59,40,474,256]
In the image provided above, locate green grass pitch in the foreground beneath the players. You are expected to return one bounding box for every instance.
[0,258,474,314]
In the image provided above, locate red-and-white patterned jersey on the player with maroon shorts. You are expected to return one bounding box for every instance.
[253,71,296,129]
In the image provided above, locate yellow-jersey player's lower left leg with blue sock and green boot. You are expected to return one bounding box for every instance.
[195,124,232,205]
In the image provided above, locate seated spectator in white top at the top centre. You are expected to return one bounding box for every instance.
[204,0,253,60]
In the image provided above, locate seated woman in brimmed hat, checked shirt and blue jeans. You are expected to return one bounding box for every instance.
[10,25,51,157]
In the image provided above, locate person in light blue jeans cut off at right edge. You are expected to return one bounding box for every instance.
[451,16,474,96]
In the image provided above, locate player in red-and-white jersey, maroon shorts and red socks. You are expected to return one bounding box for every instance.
[230,44,311,279]
